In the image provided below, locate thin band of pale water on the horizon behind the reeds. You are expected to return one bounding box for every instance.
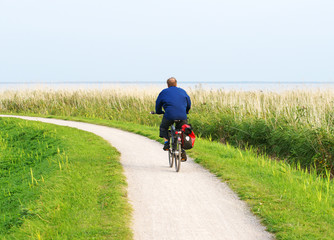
[0,81,334,92]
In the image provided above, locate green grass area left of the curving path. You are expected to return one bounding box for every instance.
[0,118,132,240]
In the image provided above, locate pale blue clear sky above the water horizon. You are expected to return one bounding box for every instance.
[0,0,334,82]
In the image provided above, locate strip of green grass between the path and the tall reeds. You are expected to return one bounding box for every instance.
[8,117,334,239]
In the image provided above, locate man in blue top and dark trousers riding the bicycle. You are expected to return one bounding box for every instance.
[155,77,191,161]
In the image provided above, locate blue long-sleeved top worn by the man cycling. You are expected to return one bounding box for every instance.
[155,87,191,120]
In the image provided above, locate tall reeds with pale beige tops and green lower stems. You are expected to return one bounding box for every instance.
[0,87,334,173]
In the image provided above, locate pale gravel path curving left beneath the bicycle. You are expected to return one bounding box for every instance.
[0,115,273,240]
